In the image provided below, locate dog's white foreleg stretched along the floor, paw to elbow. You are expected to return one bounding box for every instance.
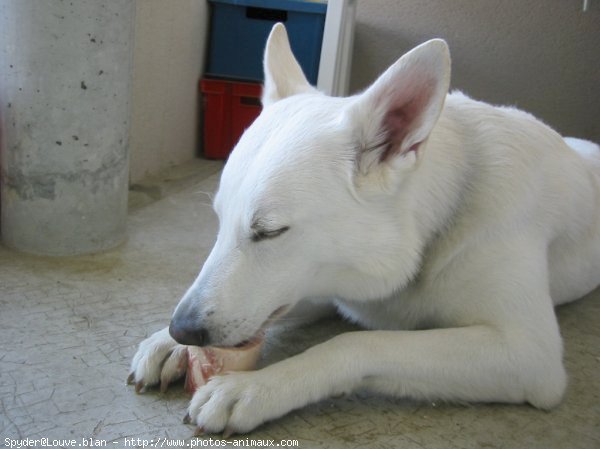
[189,316,565,434]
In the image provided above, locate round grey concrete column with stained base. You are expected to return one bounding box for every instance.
[0,0,135,255]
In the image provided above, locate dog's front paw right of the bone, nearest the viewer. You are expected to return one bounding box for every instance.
[185,371,290,438]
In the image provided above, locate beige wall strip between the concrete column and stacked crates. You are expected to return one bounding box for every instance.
[130,0,208,183]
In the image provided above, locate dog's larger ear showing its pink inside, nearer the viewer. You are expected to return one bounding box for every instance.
[347,39,450,173]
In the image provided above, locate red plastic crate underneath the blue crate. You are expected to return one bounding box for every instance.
[200,78,262,159]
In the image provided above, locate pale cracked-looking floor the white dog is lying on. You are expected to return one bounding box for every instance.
[0,159,600,449]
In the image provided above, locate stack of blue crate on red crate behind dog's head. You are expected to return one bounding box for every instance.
[200,0,327,159]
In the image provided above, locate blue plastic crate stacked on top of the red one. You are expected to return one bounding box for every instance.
[207,0,327,84]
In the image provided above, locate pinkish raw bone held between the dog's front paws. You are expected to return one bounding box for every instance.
[185,338,264,393]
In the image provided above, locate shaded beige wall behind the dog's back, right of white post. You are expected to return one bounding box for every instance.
[351,0,600,141]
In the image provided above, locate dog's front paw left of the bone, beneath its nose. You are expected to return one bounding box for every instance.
[127,328,187,393]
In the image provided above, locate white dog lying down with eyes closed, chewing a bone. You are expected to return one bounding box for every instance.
[131,25,600,434]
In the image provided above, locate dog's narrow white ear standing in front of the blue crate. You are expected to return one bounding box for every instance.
[262,23,314,106]
